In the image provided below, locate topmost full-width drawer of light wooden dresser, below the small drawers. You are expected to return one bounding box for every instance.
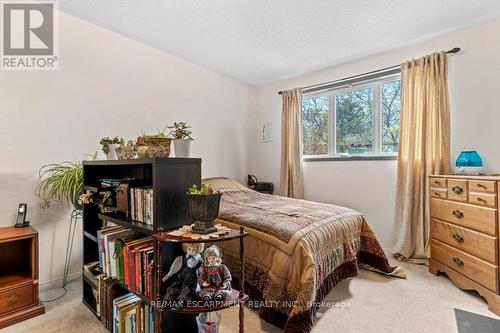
[430,198,497,236]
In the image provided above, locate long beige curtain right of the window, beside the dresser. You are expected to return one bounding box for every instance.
[394,52,450,262]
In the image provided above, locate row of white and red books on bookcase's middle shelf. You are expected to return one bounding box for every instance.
[97,226,154,298]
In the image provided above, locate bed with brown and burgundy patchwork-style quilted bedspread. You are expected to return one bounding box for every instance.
[204,178,404,333]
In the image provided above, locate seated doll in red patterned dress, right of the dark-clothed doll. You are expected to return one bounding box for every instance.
[198,245,231,302]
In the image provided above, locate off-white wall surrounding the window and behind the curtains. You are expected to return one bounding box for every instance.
[249,21,500,248]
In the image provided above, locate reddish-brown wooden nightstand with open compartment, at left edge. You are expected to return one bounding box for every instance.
[0,227,45,329]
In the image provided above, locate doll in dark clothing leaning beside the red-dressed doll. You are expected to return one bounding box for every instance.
[162,243,205,307]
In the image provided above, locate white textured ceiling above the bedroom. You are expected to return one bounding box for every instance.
[59,0,500,85]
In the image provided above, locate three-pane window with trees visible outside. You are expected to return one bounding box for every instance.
[302,72,401,161]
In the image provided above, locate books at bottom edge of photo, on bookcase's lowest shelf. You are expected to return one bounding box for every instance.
[112,293,154,333]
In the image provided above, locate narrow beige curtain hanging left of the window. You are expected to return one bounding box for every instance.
[280,89,304,198]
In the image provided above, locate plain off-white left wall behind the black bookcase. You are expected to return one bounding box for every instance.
[0,13,254,282]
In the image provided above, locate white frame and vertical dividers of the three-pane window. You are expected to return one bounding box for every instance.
[301,73,401,162]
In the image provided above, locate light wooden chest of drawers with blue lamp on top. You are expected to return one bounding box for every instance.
[429,175,500,315]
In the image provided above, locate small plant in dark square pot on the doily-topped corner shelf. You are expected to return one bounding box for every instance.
[187,184,222,234]
